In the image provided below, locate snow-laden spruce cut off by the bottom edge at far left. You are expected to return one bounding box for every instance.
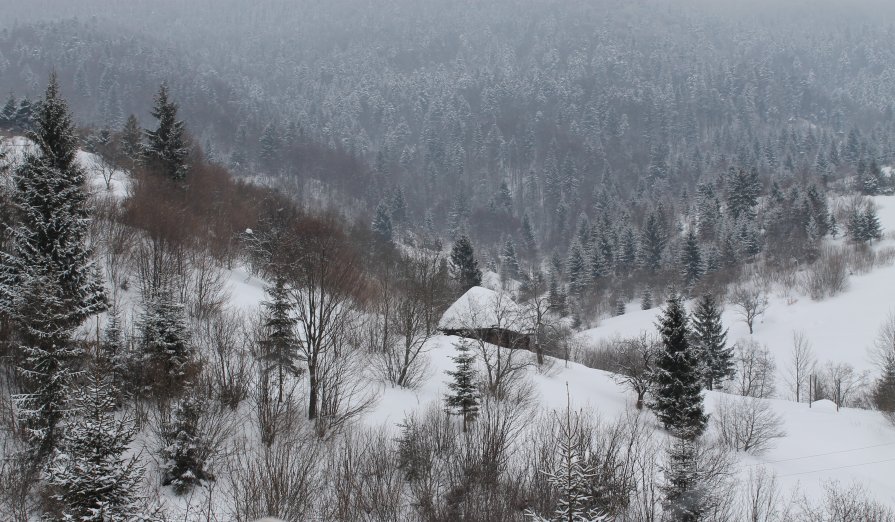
[46,368,145,522]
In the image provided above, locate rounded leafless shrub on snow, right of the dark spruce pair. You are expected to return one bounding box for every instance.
[711,395,785,455]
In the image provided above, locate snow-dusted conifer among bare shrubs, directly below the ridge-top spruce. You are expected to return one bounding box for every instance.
[138,291,193,390]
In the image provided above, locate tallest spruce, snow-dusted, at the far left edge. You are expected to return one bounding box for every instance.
[0,74,106,459]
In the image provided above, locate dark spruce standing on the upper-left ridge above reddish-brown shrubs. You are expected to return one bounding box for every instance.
[145,82,189,181]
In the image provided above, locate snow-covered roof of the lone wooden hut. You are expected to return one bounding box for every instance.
[438,286,530,332]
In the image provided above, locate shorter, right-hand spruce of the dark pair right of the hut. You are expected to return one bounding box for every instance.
[692,294,735,390]
